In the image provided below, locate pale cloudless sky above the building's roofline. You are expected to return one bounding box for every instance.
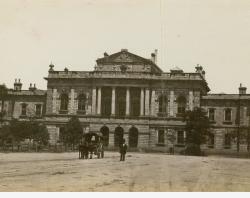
[0,0,250,93]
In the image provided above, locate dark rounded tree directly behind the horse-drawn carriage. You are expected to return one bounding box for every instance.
[61,116,83,147]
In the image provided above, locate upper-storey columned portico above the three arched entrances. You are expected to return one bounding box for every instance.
[92,86,151,117]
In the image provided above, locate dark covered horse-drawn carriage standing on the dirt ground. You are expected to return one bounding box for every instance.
[79,132,104,159]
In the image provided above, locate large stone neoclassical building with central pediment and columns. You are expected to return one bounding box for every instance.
[0,49,250,151]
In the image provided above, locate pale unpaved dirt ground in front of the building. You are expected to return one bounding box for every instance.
[0,152,250,191]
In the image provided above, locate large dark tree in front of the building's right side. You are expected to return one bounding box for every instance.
[184,108,210,155]
